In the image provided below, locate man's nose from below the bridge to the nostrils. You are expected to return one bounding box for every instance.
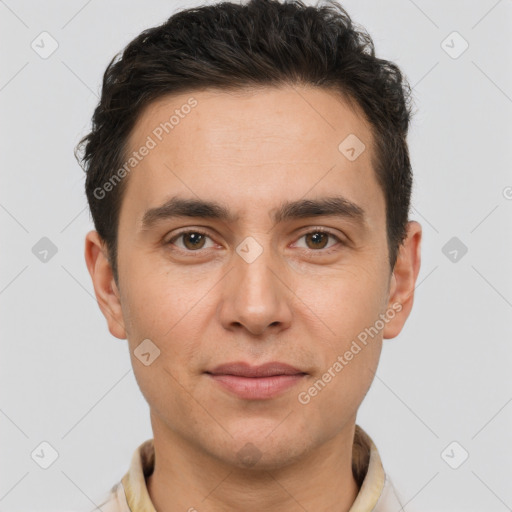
[219,249,293,336]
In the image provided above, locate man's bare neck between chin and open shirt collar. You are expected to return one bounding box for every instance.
[147,422,359,512]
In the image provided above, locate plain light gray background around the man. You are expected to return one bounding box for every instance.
[0,0,512,512]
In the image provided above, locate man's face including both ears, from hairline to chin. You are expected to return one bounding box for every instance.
[86,87,419,468]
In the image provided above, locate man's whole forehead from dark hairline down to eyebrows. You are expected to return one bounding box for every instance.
[122,86,384,230]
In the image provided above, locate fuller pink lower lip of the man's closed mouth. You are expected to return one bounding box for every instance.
[208,373,306,400]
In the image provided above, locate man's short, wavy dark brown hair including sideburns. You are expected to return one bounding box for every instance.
[75,0,412,282]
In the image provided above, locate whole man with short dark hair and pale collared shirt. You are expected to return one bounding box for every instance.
[82,0,421,512]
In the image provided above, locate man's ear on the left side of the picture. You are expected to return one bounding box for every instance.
[85,231,126,339]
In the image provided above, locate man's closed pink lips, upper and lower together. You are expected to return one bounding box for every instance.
[206,362,307,400]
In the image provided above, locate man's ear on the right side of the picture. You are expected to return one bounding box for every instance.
[383,221,421,339]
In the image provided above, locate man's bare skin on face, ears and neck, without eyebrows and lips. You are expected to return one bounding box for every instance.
[85,86,421,512]
